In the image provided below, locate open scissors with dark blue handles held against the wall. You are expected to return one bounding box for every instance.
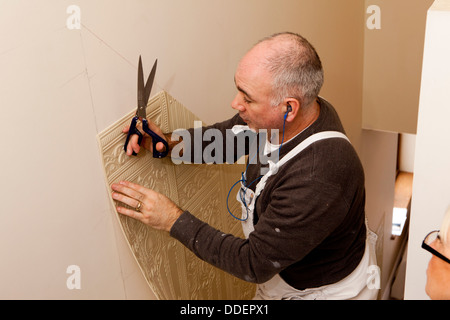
[124,56,169,158]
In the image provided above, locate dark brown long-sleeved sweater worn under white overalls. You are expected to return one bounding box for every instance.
[170,98,366,289]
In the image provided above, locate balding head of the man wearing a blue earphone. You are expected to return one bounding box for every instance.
[232,32,323,134]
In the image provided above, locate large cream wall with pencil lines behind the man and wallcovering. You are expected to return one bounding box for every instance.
[0,0,364,299]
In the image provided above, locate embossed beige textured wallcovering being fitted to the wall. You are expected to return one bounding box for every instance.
[98,91,255,299]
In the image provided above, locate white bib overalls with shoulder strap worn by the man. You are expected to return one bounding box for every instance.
[236,131,380,300]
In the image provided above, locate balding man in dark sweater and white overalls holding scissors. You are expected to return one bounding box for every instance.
[112,33,376,299]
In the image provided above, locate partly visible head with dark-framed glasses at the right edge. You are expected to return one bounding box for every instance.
[423,208,450,300]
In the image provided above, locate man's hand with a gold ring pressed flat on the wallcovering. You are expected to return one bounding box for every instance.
[111,181,183,231]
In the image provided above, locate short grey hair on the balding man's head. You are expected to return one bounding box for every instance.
[257,32,324,107]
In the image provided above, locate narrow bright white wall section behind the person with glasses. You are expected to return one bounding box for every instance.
[405,0,450,299]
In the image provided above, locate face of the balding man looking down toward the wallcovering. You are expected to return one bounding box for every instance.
[231,49,283,131]
